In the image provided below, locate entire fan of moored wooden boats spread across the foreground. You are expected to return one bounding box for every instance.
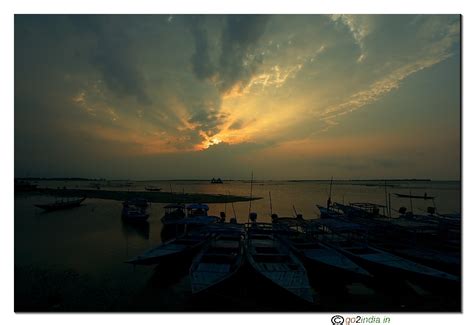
[126,205,459,302]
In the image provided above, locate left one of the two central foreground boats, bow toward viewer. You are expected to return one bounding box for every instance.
[189,229,245,294]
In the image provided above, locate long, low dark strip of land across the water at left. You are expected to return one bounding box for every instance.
[29,188,261,203]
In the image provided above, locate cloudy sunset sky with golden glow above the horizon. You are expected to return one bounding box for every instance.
[14,15,461,180]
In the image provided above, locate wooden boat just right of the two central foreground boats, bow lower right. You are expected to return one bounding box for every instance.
[280,234,372,277]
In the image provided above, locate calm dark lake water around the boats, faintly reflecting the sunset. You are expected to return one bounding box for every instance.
[15,181,461,311]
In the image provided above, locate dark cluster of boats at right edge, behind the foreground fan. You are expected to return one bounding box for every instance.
[318,199,461,275]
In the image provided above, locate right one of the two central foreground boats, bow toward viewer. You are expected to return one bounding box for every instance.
[245,229,313,302]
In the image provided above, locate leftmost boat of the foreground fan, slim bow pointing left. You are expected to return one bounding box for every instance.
[125,233,210,265]
